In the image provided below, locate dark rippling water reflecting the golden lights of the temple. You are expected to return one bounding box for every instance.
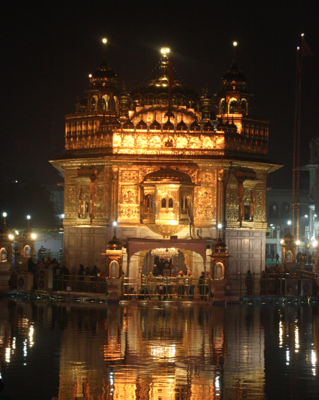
[0,299,319,400]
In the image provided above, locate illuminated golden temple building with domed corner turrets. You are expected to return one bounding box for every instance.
[52,49,277,277]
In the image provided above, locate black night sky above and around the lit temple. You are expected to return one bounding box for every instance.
[0,0,319,187]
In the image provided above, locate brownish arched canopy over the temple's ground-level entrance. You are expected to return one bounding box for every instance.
[127,238,209,268]
